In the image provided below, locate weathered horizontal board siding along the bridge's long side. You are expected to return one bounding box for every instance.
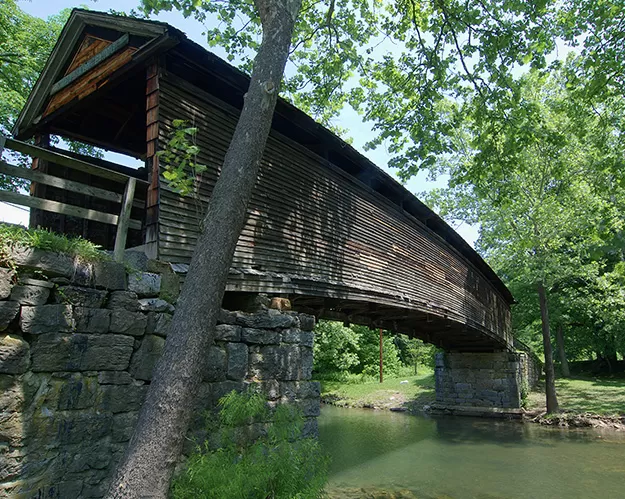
[158,76,510,343]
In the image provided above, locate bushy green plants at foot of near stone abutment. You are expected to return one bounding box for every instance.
[172,392,328,499]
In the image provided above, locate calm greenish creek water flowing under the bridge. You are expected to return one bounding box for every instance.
[319,405,625,499]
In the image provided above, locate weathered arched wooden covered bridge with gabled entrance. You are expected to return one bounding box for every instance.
[5,10,512,352]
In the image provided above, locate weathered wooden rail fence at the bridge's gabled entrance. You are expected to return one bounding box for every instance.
[0,134,148,261]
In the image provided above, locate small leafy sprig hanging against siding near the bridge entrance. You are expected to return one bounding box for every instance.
[156,120,206,197]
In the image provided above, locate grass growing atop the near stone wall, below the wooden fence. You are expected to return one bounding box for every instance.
[0,224,110,264]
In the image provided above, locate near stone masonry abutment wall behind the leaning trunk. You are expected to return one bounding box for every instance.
[0,249,319,499]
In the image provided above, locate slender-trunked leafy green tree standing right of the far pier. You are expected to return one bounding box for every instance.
[430,70,623,412]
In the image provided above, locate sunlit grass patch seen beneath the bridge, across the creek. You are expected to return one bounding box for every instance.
[321,367,435,409]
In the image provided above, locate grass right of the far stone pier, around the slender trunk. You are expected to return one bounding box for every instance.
[528,377,625,416]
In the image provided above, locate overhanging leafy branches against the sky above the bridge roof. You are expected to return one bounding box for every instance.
[142,0,556,158]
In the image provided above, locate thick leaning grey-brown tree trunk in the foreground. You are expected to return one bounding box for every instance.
[107,0,301,499]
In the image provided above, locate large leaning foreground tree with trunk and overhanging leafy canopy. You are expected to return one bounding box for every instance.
[109,0,620,497]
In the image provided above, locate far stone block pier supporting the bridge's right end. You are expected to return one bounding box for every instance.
[433,352,536,415]
